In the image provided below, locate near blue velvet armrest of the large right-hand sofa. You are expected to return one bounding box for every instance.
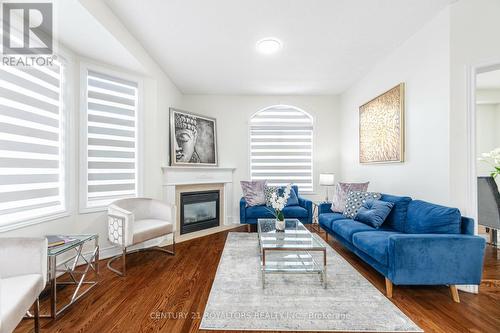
[388,234,485,285]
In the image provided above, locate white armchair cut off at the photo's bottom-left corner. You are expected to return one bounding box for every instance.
[0,238,47,333]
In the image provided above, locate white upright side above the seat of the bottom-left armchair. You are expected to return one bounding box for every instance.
[0,238,47,286]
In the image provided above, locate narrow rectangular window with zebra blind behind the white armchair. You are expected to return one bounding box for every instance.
[80,69,139,211]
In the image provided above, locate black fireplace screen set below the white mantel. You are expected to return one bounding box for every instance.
[180,191,219,234]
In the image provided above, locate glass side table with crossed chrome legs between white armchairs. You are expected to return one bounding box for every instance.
[45,234,99,319]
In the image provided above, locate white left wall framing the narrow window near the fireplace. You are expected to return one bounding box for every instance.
[0,1,181,256]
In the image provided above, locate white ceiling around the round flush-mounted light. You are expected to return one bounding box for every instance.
[105,0,453,94]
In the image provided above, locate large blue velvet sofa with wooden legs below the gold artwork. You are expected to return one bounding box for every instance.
[318,194,485,302]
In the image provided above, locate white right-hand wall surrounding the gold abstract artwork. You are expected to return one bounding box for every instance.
[336,9,450,204]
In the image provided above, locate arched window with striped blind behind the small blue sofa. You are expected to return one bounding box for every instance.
[249,105,313,192]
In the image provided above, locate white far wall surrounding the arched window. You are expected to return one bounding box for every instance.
[180,95,340,219]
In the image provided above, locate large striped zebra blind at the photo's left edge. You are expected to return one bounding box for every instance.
[0,62,66,227]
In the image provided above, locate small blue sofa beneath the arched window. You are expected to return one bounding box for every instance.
[240,185,312,225]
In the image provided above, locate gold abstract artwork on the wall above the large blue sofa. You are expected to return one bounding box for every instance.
[359,83,404,163]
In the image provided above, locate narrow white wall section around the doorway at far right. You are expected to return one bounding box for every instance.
[449,0,500,216]
